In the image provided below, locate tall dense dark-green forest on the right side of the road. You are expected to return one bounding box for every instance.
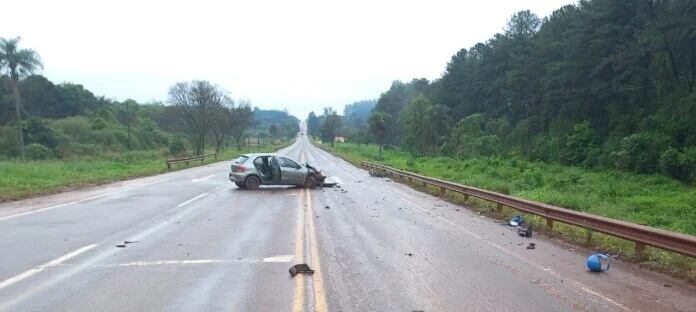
[318,0,696,181]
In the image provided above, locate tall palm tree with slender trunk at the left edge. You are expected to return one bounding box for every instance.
[0,37,43,160]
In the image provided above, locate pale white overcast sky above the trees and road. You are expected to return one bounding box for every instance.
[0,0,575,119]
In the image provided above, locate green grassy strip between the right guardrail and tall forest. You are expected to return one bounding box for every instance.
[327,143,696,235]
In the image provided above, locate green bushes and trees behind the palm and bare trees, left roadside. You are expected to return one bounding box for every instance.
[0,75,299,159]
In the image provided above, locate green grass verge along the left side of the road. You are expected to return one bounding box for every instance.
[0,141,291,202]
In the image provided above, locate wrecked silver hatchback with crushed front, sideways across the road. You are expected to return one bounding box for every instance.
[230,154,326,190]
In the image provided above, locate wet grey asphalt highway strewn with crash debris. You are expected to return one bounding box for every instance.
[0,136,696,311]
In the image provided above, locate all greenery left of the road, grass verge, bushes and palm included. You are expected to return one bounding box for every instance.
[0,38,299,202]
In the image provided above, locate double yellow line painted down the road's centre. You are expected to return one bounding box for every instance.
[293,153,328,312]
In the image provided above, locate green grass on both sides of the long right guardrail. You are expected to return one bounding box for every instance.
[323,143,696,282]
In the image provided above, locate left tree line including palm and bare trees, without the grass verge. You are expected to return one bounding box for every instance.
[0,38,299,159]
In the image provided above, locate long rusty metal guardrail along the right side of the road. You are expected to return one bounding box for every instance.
[362,161,696,257]
